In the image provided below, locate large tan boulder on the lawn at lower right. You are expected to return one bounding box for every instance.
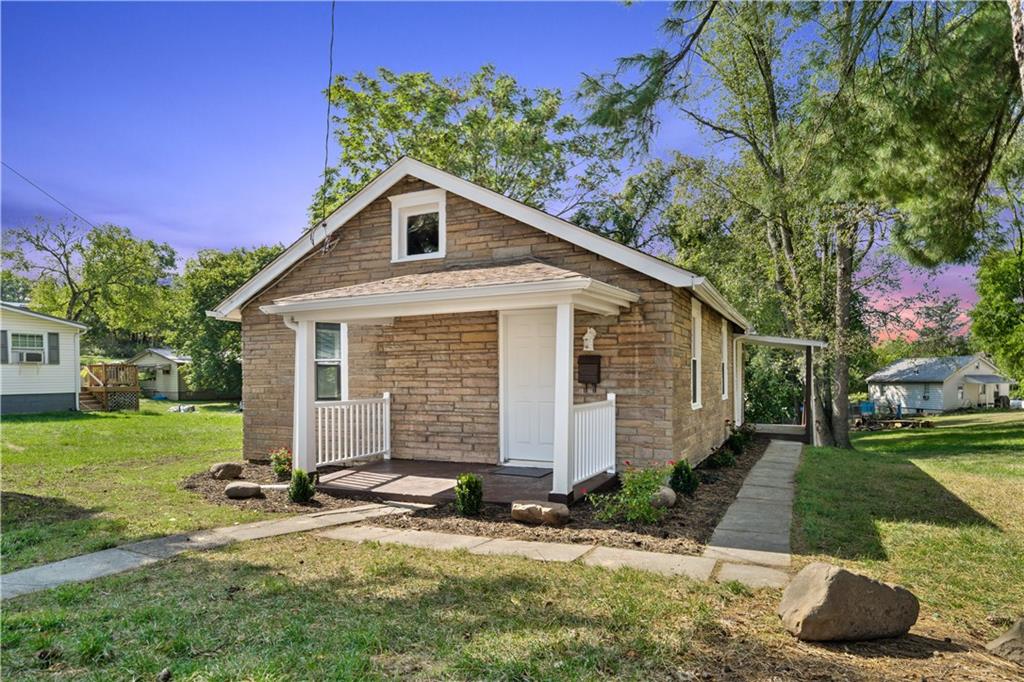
[778,562,921,642]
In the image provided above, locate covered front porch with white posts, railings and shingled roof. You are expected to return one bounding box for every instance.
[261,261,639,502]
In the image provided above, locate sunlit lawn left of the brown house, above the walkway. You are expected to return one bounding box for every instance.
[0,400,272,572]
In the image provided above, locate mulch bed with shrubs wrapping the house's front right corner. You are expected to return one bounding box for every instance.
[374,438,768,554]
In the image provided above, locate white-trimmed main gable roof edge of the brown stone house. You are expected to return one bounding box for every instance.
[207,157,751,329]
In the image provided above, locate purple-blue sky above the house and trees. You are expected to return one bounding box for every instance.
[0,2,974,323]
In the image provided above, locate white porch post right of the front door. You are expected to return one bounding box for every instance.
[549,303,574,502]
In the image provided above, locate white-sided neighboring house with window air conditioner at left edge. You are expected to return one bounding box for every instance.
[0,302,88,415]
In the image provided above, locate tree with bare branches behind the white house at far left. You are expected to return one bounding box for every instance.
[4,219,176,337]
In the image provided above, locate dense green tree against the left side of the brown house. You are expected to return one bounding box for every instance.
[167,245,284,394]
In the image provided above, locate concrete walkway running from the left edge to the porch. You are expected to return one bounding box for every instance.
[0,504,415,599]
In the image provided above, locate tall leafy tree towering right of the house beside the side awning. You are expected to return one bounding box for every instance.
[581,2,1021,446]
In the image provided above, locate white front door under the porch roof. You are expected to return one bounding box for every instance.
[502,309,555,464]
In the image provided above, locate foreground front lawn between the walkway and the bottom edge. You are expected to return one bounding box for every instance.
[2,535,758,680]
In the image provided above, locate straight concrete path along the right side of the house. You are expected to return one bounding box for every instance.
[703,440,803,587]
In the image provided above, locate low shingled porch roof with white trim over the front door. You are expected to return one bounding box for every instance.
[260,260,640,321]
